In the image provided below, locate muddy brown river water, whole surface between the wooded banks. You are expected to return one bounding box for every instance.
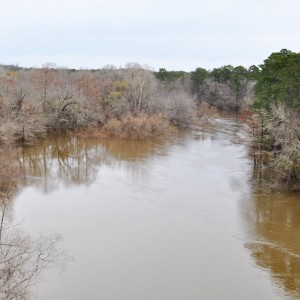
[12,117,300,300]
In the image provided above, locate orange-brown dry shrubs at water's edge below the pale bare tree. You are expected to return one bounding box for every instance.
[103,113,171,140]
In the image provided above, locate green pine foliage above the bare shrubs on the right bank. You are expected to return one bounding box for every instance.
[252,49,300,111]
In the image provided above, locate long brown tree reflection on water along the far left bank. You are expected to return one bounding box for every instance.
[18,136,171,192]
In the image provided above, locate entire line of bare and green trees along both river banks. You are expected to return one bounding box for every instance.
[0,49,300,189]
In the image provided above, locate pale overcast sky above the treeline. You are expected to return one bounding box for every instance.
[0,0,300,71]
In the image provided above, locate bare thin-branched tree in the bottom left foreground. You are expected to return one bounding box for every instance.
[0,193,69,300]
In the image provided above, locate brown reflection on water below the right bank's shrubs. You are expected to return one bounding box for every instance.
[243,186,300,299]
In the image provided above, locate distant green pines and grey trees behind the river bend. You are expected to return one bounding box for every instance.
[155,65,260,110]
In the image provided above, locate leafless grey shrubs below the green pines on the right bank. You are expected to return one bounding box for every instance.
[240,105,300,189]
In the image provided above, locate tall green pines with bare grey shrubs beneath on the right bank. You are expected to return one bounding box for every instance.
[243,49,300,189]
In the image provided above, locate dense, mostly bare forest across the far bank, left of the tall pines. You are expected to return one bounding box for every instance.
[0,63,258,144]
